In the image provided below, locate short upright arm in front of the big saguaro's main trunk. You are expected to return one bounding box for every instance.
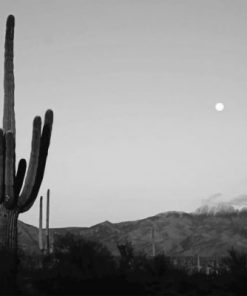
[4,131,15,209]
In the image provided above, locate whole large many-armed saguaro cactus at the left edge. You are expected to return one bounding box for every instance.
[0,15,53,250]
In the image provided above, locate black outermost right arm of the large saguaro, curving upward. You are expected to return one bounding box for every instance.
[19,110,53,213]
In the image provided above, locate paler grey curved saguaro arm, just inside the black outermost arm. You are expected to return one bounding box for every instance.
[17,116,41,207]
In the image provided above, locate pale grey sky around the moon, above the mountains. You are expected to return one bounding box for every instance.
[0,0,247,227]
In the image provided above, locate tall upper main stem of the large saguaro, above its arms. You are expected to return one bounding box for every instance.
[3,15,15,139]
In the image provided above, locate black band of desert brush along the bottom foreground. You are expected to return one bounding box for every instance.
[0,234,247,296]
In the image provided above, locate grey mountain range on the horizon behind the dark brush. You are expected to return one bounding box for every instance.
[18,211,247,256]
